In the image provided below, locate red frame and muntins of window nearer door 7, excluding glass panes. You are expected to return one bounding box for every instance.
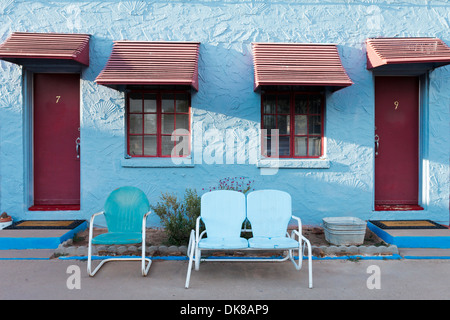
[126,90,191,158]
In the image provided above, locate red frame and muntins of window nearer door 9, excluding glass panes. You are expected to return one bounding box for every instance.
[261,91,325,159]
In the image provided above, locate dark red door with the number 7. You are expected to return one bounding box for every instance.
[30,73,80,210]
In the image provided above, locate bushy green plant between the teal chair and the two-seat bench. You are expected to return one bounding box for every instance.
[151,189,200,246]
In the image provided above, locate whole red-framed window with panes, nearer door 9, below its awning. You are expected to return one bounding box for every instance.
[261,92,324,158]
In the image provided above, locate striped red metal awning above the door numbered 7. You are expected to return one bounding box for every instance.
[0,32,90,66]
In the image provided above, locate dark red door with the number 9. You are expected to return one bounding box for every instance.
[375,77,419,210]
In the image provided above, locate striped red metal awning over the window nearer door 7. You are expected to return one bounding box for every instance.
[95,41,200,91]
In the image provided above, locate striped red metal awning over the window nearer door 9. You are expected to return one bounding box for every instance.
[253,43,353,91]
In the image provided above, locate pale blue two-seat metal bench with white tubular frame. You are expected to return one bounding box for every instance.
[185,190,313,288]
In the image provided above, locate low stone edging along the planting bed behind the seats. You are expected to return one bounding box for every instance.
[54,239,399,257]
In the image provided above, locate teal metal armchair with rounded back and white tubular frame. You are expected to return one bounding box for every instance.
[87,187,152,277]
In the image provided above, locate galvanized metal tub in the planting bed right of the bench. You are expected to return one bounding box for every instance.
[322,217,367,246]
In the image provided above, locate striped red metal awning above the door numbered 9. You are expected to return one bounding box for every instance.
[366,38,450,70]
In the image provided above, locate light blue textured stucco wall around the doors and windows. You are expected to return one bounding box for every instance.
[0,0,450,225]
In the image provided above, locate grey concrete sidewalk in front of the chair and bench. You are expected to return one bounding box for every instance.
[0,254,450,302]
